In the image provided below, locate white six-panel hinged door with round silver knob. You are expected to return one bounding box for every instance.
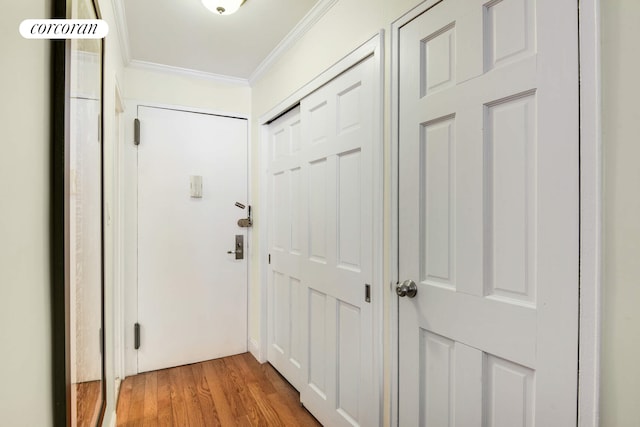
[398,0,579,427]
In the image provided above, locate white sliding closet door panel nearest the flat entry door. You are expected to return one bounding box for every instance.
[267,108,306,390]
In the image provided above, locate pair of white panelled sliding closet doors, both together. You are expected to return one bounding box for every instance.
[268,59,379,426]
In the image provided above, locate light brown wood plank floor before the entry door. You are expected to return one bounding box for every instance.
[117,353,320,427]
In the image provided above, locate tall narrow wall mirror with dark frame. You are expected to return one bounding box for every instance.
[52,0,106,427]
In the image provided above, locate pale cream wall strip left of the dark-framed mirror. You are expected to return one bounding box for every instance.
[0,0,53,427]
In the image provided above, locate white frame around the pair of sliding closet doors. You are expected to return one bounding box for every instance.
[256,34,387,423]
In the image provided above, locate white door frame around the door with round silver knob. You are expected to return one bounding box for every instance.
[388,0,602,427]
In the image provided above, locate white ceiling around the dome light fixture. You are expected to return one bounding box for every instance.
[119,0,320,80]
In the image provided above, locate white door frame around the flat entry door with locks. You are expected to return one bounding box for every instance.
[121,99,253,377]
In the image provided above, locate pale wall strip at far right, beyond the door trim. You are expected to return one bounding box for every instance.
[600,0,640,427]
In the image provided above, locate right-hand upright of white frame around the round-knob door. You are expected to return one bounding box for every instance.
[578,0,603,427]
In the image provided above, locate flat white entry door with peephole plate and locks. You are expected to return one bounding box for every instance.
[138,106,248,372]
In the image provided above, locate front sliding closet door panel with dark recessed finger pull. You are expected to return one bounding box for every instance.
[301,59,376,426]
